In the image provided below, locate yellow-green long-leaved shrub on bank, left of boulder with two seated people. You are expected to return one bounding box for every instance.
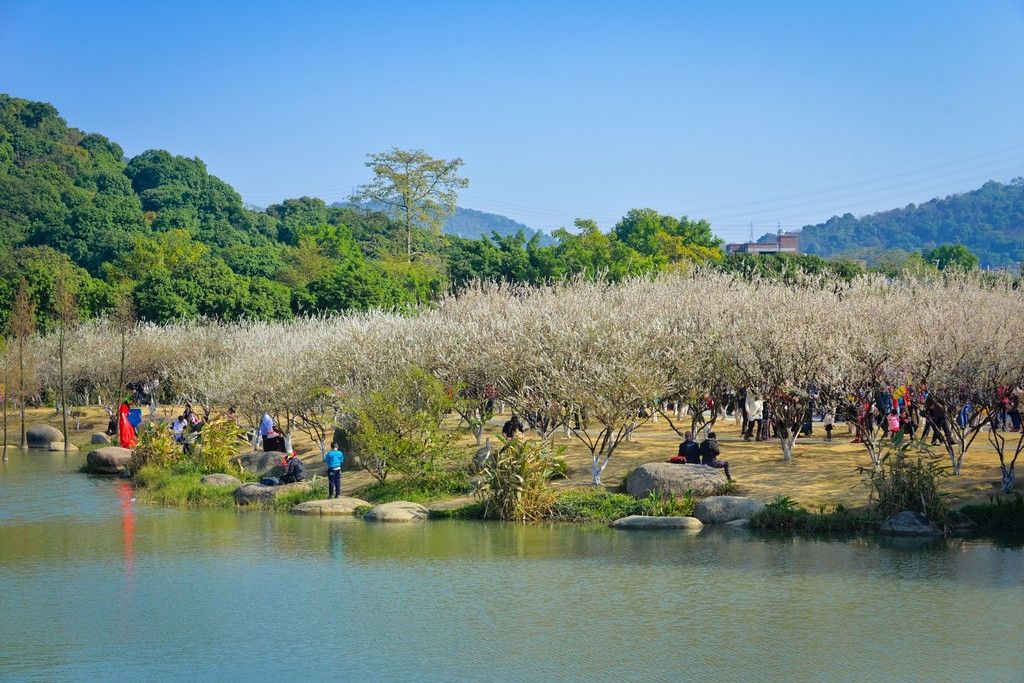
[475,438,558,522]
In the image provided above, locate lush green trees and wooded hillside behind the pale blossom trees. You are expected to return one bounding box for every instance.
[0,94,1011,332]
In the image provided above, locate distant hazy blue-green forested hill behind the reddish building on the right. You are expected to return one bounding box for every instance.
[773,178,1024,266]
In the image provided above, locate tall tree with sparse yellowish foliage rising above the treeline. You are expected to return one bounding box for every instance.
[352,147,469,261]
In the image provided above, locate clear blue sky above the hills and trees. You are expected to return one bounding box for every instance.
[0,0,1024,239]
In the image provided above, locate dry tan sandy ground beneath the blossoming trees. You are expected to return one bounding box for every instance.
[7,407,1015,507]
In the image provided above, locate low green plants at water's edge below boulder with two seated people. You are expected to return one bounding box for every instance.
[551,488,694,523]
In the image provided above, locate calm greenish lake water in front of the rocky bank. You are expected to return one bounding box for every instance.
[0,452,1024,681]
